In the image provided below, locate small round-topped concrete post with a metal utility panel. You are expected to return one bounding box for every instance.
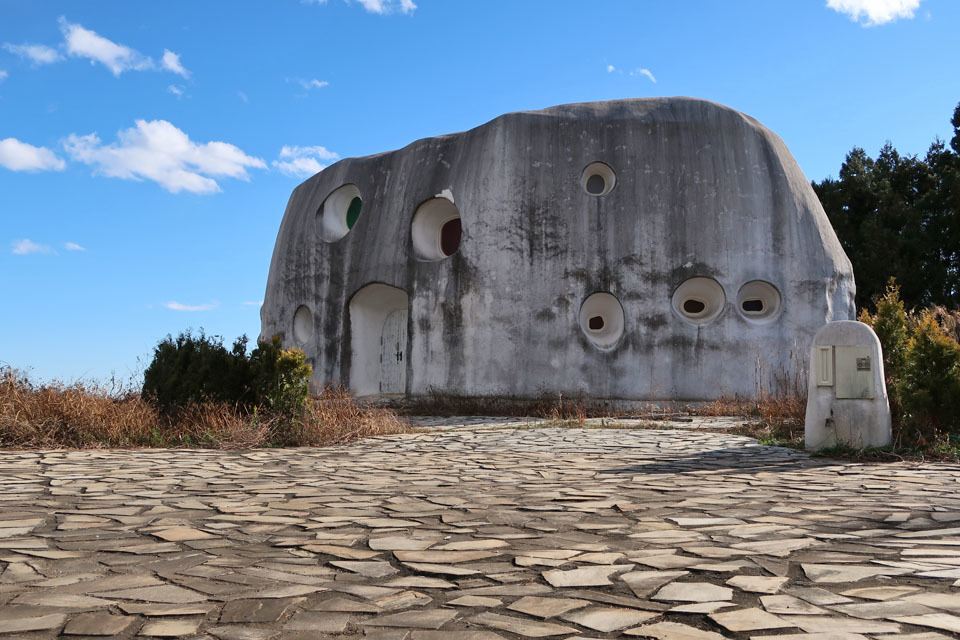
[804,320,892,451]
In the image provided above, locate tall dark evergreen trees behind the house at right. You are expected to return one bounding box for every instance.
[811,104,960,309]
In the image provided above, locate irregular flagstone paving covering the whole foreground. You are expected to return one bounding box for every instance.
[0,421,960,640]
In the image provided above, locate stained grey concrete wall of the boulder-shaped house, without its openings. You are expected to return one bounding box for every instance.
[261,98,854,400]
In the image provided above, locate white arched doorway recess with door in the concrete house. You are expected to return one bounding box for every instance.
[349,283,410,396]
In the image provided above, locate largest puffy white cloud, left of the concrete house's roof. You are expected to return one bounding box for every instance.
[63,120,267,193]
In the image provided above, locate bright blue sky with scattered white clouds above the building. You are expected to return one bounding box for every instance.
[0,0,960,381]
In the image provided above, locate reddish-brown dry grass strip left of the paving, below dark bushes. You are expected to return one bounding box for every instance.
[0,369,410,449]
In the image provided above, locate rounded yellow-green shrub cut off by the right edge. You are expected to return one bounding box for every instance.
[898,310,960,439]
